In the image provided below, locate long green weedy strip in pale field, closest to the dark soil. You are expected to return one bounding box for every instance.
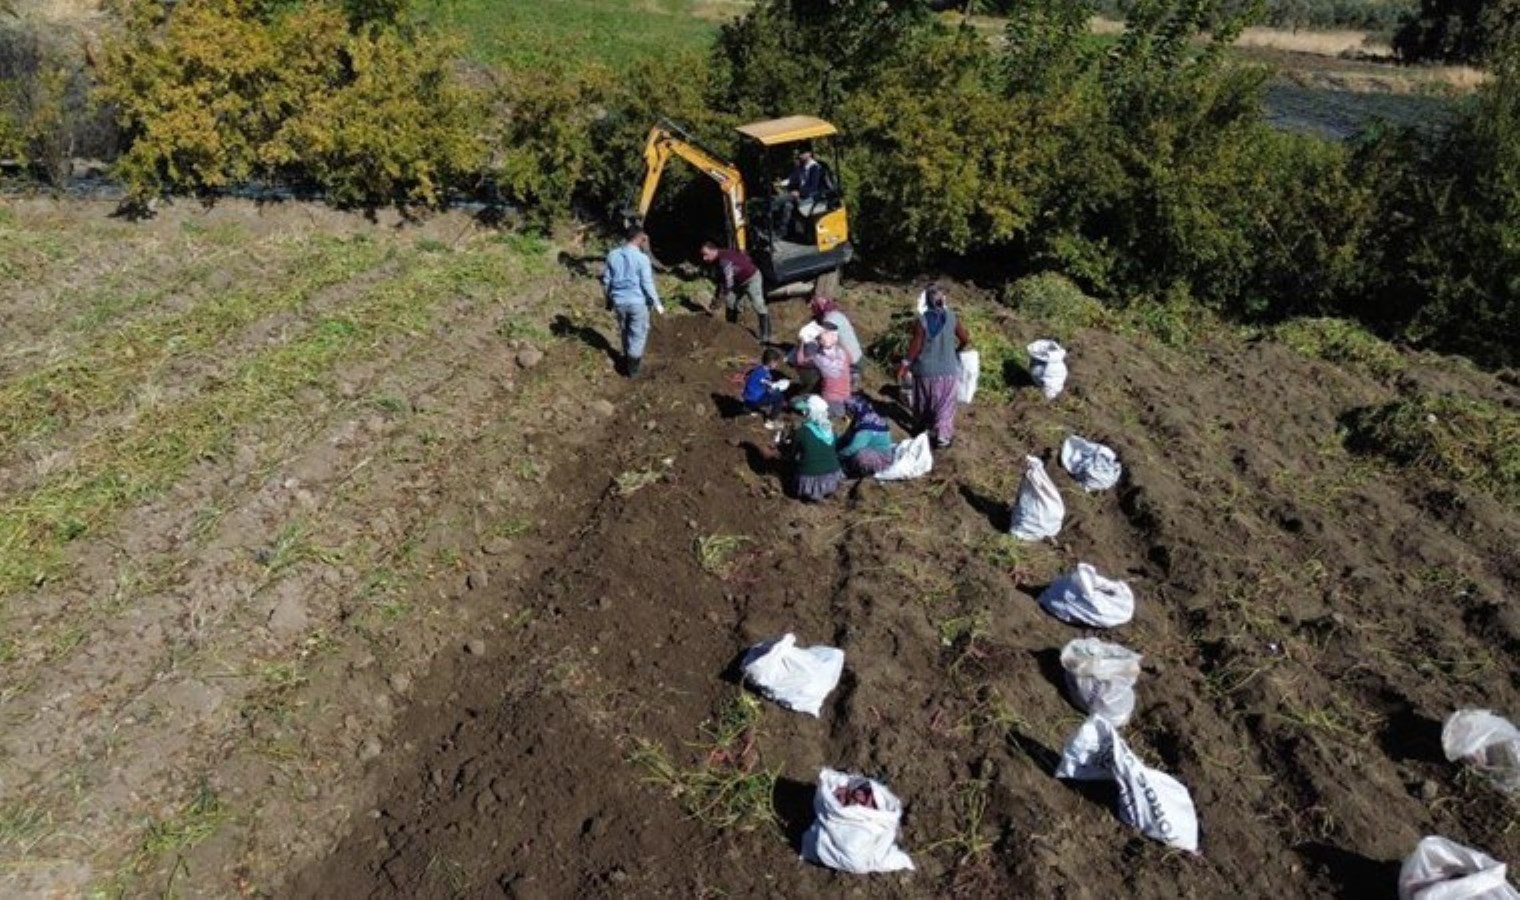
[0,243,535,596]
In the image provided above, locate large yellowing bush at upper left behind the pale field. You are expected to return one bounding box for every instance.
[100,0,480,204]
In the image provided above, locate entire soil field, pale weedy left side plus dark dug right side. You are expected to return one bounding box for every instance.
[0,201,1520,897]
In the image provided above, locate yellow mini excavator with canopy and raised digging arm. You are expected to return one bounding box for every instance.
[628,116,854,293]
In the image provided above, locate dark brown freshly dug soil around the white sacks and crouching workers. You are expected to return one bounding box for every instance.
[289,304,1520,897]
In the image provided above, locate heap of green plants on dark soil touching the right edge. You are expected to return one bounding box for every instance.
[1341,394,1520,503]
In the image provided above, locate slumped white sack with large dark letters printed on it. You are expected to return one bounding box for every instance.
[1055,716,1198,853]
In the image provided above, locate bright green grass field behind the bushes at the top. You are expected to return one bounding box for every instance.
[423,0,717,70]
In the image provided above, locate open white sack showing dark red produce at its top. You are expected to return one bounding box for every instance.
[803,769,914,874]
